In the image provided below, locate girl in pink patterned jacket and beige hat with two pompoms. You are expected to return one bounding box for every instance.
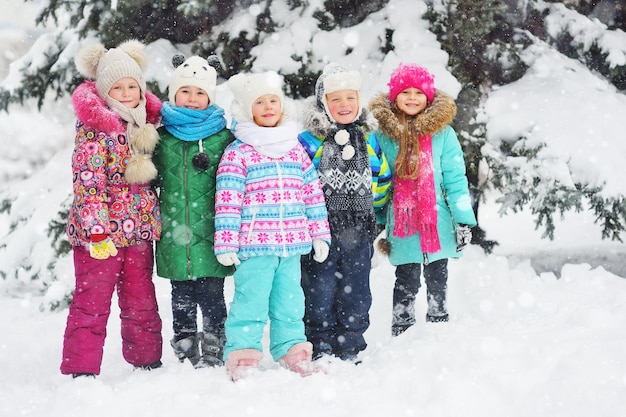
[61,40,162,377]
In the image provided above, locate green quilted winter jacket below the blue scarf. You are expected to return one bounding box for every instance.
[153,127,234,281]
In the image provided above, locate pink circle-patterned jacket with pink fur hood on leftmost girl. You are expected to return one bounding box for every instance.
[67,81,161,247]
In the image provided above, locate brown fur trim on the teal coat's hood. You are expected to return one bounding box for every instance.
[369,90,456,138]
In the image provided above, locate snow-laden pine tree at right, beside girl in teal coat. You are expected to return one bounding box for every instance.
[427,0,626,240]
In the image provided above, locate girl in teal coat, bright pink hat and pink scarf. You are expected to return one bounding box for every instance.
[370,64,476,336]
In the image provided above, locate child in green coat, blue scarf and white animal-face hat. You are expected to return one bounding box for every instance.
[154,55,234,368]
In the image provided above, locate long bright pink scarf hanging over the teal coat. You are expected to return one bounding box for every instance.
[393,135,441,253]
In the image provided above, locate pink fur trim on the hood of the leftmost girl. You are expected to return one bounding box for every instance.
[72,81,162,132]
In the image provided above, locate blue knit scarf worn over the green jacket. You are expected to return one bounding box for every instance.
[161,101,226,141]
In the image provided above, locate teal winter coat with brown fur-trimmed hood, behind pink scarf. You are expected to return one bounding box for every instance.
[370,91,476,265]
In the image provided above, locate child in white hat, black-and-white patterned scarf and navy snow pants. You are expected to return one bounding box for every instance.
[298,64,390,363]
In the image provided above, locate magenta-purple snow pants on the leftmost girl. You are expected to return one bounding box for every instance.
[61,242,163,375]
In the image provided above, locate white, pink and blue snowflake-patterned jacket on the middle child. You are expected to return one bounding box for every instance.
[215,139,330,260]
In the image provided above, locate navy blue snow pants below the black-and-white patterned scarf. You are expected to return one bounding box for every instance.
[302,236,373,360]
